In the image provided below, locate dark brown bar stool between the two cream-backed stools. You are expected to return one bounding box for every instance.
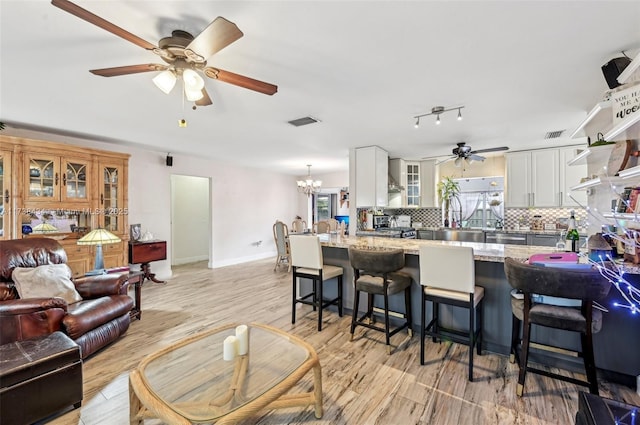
[349,246,412,354]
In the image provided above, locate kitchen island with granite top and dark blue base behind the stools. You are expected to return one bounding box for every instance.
[312,235,640,386]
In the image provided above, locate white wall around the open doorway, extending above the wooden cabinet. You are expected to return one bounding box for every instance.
[4,129,301,279]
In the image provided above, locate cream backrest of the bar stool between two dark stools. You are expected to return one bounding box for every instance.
[420,245,476,294]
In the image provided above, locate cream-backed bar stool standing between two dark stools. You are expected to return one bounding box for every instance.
[420,245,484,381]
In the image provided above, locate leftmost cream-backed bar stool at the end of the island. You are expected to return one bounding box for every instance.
[289,234,344,331]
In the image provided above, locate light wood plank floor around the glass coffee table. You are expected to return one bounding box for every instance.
[45,260,640,425]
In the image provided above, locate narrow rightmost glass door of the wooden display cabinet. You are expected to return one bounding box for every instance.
[100,165,127,233]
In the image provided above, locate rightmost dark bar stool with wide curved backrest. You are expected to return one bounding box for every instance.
[504,258,611,397]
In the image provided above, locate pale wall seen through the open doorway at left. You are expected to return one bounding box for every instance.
[171,175,211,266]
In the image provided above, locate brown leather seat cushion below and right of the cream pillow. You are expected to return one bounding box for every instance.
[62,295,133,339]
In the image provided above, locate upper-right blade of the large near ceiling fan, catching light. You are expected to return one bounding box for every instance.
[185,16,244,62]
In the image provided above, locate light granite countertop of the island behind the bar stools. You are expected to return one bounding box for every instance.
[320,235,556,263]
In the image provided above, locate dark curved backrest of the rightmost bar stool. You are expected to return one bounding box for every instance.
[504,258,611,301]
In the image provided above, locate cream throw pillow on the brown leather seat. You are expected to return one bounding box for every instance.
[11,264,82,304]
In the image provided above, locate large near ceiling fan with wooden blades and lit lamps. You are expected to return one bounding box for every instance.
[51,0,278,108]
